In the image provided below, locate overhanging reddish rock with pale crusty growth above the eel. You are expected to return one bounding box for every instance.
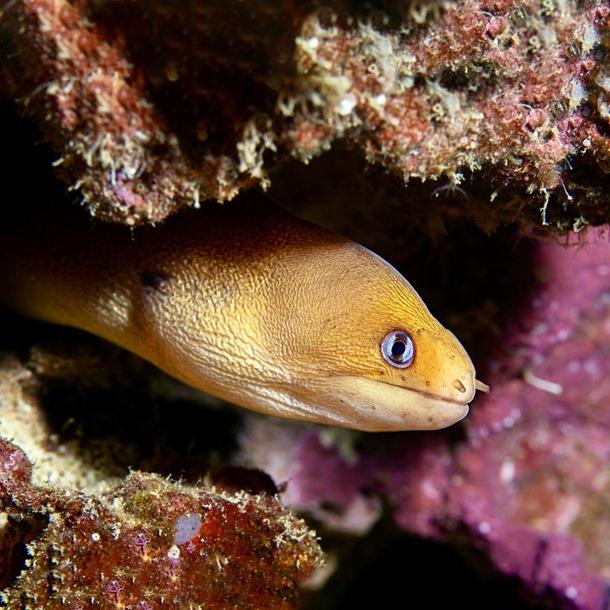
[0,0,610,230]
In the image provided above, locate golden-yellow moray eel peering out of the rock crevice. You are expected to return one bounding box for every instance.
[0,193,487,431]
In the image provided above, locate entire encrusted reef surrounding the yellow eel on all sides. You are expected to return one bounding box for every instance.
[0,0,610,610]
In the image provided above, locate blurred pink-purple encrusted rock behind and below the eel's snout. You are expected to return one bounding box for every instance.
[242,232,610,610]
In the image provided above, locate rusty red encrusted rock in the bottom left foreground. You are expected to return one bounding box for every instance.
[0,438,321,610]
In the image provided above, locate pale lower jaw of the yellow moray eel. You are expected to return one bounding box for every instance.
[308,376,473,432]
